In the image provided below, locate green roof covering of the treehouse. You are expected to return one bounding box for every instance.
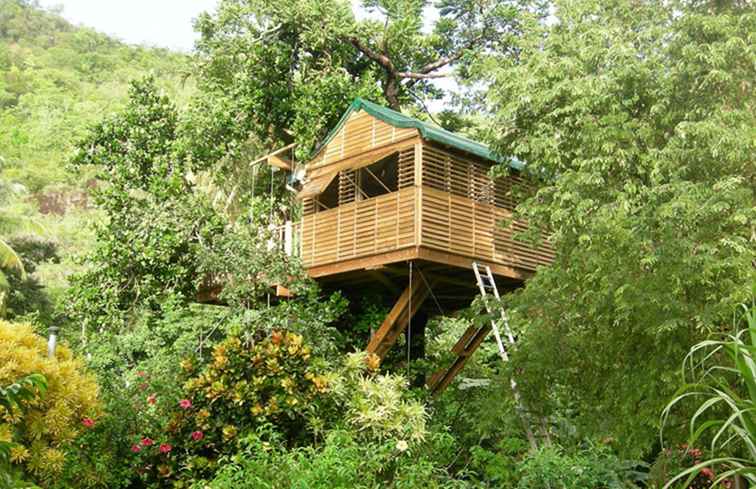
[315,98,525,170]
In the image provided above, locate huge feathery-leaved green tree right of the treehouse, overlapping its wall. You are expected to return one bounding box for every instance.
[475,0,756,456]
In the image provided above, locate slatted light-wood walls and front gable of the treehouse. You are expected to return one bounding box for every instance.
[300,134,553,271]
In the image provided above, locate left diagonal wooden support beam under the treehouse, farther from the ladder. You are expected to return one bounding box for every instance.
[367,274,430,358]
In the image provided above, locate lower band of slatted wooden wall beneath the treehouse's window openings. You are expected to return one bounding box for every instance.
[301,186,553,278]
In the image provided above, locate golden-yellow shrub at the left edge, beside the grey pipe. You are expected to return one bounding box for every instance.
[0,321,100,485]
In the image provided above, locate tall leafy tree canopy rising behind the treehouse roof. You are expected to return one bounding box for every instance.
[187,0,517,169]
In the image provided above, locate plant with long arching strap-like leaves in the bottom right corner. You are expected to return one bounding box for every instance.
[663,288,756,488]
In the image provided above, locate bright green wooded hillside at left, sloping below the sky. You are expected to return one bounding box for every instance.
[0,0,193,308]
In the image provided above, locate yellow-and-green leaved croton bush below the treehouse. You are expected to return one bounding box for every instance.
[180,331,329,453]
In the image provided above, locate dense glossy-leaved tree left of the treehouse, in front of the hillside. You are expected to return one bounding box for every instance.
[69,78,223,329]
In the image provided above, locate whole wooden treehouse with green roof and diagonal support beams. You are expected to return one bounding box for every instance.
[280,99,552,392]
